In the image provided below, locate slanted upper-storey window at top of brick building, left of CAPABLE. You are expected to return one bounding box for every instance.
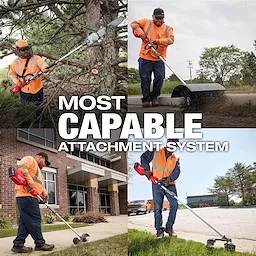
[18,128,55,148]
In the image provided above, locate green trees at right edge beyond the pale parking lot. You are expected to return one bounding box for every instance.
[208,162,256,206]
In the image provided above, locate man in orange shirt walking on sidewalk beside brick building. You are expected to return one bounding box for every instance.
[12,152,54,253]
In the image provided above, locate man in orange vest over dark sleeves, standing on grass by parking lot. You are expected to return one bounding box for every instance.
[140,139,180,238]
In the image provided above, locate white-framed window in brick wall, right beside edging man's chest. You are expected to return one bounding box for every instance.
[42,167,57,204]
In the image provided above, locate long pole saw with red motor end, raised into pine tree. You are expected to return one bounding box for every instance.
[10,16,125,93]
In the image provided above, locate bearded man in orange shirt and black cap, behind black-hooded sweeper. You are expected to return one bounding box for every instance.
[131,8,174,107]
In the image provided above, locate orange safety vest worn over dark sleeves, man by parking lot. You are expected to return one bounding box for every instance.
[152,148,177,184]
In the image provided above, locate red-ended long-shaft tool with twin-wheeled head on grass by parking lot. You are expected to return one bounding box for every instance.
[134,163,236,251]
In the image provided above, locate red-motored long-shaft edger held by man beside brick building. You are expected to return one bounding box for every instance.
[8,167,89,244]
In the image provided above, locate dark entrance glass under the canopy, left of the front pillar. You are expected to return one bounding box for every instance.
[68,185,87,215]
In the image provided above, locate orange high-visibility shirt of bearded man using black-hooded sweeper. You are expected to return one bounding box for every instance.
[131,18,174,60]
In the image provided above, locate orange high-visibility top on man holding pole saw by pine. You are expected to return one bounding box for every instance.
[10,55,48,94]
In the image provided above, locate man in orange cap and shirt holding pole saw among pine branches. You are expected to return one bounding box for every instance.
[10,40,48,103]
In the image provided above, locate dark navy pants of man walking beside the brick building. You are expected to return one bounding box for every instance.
[13,196,45,248]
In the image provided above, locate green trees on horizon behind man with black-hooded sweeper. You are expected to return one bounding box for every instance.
[128,40,256,87]
